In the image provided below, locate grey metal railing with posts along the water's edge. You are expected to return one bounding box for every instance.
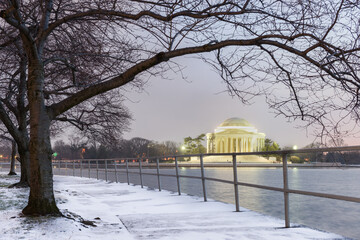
[53,146,360,228]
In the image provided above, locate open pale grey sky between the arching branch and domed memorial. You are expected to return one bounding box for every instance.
[124,59,338,147]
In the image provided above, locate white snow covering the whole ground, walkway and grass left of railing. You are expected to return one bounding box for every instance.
[0,174,343,240]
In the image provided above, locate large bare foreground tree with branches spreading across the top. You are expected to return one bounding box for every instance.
[0,0,359,218]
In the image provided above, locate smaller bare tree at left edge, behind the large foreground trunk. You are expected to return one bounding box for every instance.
[0,41,30,187]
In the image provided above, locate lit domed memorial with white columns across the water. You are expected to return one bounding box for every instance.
[206,118,265,153]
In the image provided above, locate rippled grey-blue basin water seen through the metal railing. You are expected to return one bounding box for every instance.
[55,167,360,239]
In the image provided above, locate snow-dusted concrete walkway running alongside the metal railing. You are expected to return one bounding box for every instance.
[55,177,341,240]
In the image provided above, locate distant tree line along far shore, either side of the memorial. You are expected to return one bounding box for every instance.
[28,134,360,164]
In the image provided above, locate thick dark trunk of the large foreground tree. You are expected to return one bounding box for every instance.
[23,60,60,216]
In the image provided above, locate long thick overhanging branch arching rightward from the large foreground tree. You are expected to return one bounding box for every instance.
[48,35,358,119]
